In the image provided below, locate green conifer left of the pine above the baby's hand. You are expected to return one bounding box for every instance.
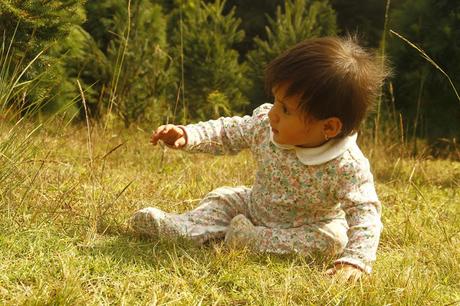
[107,0,170,126]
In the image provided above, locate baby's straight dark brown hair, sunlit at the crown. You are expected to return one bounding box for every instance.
[265,36,389,137]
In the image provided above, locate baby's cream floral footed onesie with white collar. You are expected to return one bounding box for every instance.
[131,104,382,273]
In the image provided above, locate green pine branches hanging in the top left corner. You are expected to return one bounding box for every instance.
[0,0,85,113]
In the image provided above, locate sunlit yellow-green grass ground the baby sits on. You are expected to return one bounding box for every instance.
[0,124,460,305]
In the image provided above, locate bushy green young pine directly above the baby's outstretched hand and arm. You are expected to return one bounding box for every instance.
[171,0,249,120]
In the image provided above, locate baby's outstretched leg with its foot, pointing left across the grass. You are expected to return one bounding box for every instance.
[130,187,251,243]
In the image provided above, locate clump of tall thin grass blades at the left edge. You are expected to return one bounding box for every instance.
[0,27,44,195]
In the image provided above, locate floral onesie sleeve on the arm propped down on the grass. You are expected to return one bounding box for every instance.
[334,153,383,273]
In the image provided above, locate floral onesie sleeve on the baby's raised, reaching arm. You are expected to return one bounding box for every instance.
[181,103,271,154]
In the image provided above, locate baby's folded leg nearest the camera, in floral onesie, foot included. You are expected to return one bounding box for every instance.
[225,216,348,256]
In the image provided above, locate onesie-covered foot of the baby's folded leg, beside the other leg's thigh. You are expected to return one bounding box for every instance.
[225,215,257,248]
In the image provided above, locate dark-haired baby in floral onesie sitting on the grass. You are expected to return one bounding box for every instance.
[130,37,386,278]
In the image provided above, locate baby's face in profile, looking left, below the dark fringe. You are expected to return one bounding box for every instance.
[268,84,326,148]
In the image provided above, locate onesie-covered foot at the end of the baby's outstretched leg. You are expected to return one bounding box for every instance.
[129,207,187,237]
